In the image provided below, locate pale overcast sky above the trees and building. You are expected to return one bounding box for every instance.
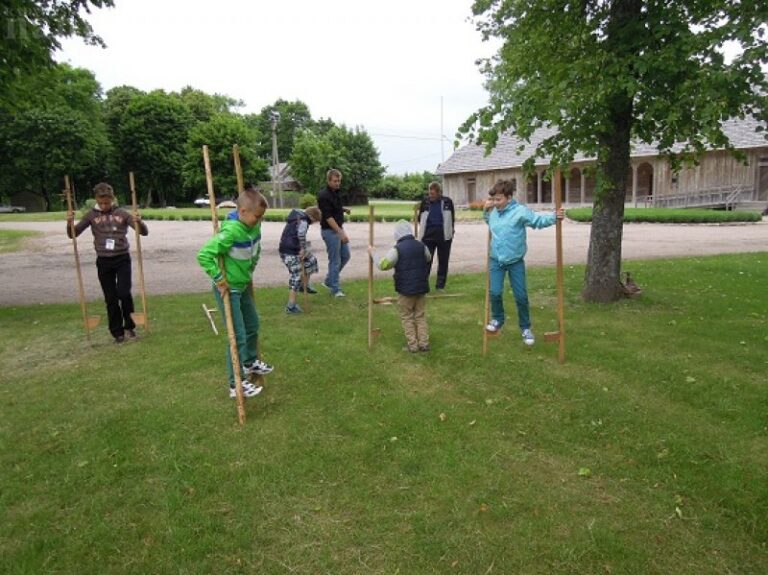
[58,0,492,174]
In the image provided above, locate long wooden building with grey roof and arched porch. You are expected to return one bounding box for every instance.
[437,118,768,210]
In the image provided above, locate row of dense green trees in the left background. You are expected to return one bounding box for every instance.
[0,64,384,209]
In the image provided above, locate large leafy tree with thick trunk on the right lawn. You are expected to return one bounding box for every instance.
[462,0,768,302]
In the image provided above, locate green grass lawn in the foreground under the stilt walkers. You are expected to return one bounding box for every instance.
[0,253,768,575]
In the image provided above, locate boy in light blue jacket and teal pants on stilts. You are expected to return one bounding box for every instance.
[483,180,564,345]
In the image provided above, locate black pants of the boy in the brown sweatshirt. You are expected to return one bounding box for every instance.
[96,254,136,337]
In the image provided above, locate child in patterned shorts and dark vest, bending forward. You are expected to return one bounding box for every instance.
[279,206,321,314]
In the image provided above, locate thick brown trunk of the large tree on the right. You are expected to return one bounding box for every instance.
[582,0,642,302]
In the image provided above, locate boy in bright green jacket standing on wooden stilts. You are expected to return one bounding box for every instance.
[197,189,273,398]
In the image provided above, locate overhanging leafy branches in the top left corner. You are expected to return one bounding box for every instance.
[0,0,113,108]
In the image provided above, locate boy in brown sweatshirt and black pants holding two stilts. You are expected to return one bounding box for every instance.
[67,182,149,343]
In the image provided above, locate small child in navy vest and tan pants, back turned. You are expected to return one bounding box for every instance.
[368,220,432,353]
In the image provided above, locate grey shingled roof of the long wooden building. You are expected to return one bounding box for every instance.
[436,116,768,175]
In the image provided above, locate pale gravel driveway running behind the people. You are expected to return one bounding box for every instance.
[0,218,768,307]
